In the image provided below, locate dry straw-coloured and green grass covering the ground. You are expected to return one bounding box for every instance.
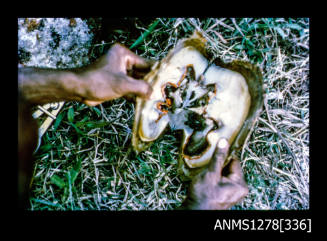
[30,18,309,210]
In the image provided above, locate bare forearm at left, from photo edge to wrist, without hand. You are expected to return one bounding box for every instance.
[18,67,87,104]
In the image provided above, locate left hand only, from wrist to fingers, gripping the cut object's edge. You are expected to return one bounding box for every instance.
[81,44,152,106]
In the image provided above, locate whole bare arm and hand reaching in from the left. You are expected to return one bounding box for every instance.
[18,45,152,106]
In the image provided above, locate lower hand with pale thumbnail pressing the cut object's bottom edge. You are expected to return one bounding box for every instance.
[182,138,248,210]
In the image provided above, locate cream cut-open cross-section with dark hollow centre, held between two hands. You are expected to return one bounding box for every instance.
[132,32,264,176]
